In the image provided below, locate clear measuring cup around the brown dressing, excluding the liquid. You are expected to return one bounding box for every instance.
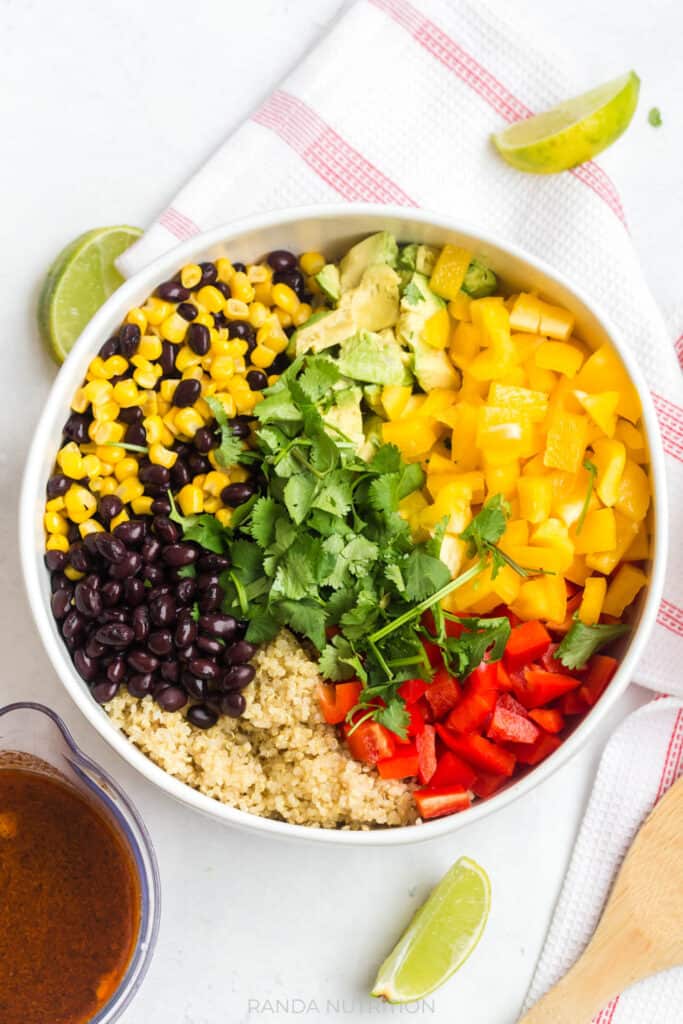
[0,702,161,1024]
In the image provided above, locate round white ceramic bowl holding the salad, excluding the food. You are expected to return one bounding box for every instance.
[19,205,667,846]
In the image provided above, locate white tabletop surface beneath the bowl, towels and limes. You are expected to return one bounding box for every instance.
[0,0,683,1024]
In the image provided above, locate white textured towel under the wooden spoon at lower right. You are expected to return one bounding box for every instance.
[525,698,683,1024]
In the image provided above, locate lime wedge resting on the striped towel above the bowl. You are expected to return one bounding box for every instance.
[492,71,640,174]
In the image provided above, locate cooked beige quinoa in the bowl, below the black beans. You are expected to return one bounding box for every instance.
[106,631,416,828]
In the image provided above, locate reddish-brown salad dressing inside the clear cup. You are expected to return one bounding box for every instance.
[0,767,140,1024]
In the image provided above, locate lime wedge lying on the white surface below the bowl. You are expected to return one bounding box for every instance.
[372,857,490,1002]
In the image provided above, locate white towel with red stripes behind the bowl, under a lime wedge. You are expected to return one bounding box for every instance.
[120,0,683,695]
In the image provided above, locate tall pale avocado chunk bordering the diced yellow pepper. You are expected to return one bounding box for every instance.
[396,272,461,391]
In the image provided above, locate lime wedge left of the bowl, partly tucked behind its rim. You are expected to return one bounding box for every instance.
[38,226,142,362]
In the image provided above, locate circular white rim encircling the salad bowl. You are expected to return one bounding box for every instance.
[18,203,668,846]
